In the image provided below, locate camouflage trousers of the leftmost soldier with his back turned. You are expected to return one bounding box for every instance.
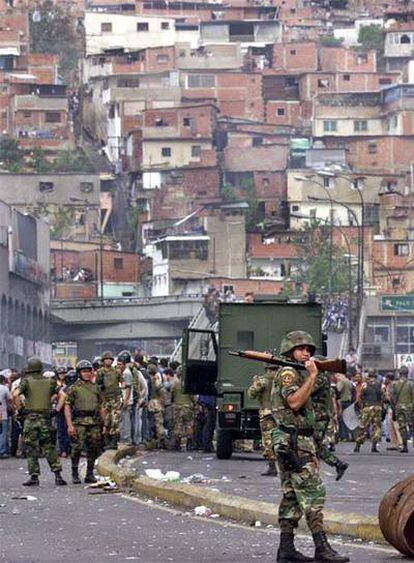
[23,414,62,475]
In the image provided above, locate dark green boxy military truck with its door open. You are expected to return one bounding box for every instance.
[182,298,326,459]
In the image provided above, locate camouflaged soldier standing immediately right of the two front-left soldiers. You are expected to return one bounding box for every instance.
[96,352,121,449]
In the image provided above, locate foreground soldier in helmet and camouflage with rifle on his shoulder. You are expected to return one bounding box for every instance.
[272,330,349,563]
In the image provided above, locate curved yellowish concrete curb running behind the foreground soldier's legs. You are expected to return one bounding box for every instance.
[97,447,386,543]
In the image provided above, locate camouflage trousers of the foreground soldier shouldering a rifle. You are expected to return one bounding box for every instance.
[279,452,326,534]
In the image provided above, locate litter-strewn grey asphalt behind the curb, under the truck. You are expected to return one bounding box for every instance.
[133,443,414,515]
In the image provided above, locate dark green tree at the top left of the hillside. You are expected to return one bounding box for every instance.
[30,0,80,84]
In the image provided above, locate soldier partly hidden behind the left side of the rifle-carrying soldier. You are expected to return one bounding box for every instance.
[247,368,277,476]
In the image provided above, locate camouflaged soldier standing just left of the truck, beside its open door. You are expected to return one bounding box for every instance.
[171,368,197,451]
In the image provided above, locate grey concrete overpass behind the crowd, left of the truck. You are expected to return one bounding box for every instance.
[52,295,202,357]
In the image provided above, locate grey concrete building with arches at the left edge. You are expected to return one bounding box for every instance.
[0,202,52,369]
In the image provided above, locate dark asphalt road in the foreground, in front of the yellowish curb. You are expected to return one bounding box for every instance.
[0,459,408,563]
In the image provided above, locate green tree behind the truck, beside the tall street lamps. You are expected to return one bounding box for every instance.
[292,223,355,293]
